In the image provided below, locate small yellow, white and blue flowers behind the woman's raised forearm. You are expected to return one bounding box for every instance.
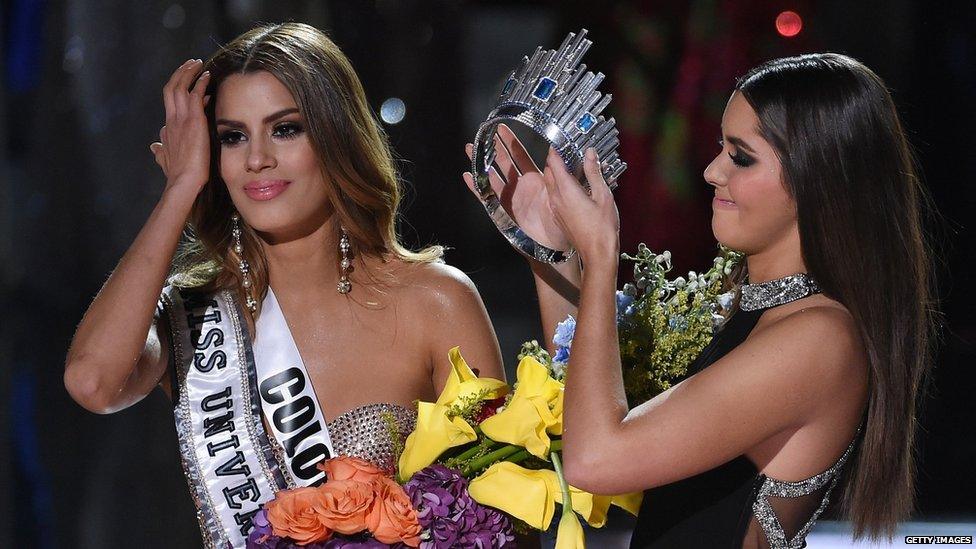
[536,244,742,407]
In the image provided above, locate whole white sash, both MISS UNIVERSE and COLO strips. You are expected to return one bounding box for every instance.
[161,286,332,548]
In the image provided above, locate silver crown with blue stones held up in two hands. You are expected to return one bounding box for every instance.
[471,29,627,263]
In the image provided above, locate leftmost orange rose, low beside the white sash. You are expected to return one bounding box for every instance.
[264,488,332,545]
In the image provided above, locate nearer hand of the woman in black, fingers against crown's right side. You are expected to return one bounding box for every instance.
[546,144,620,265]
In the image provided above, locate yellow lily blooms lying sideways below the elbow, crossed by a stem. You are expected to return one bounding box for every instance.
[468,461,643,530]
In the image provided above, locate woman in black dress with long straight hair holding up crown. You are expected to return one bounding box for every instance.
[465,53,935,548]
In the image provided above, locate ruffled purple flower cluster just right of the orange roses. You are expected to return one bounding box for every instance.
[403,464,515,549]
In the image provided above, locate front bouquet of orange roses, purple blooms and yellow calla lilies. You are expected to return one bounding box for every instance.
[248,347,642,549]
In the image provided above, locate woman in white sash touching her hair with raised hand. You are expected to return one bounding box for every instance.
[64,23,504,547]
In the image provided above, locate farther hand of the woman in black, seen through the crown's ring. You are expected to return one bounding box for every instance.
[463,124,570,250]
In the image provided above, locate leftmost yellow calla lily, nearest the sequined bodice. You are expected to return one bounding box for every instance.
[399,347,508,480]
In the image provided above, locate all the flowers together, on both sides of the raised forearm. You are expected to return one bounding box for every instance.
[242,244,741,549]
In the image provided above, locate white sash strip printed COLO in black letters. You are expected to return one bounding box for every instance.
[253,287,334,486]
